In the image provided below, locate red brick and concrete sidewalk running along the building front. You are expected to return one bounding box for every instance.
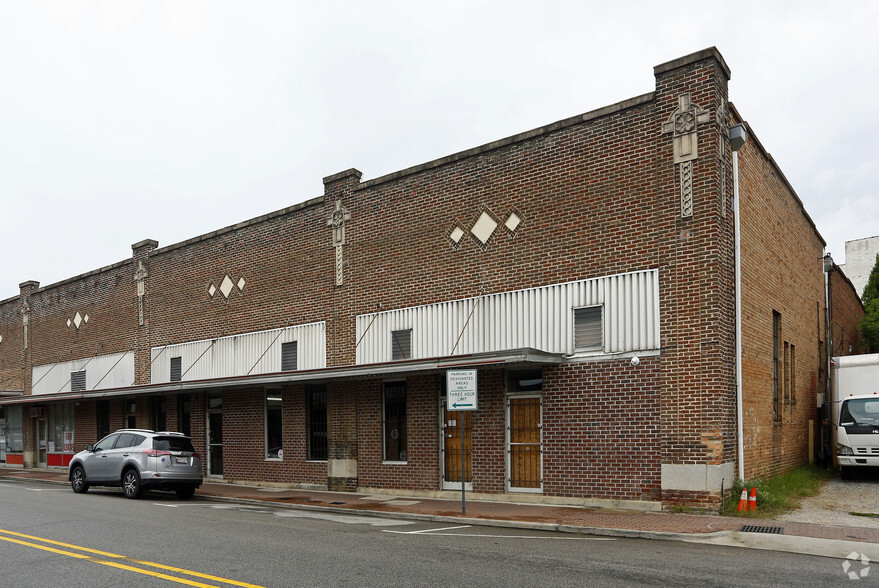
[0,467,879,561]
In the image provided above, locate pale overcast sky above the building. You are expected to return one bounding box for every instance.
[0,0,879,300]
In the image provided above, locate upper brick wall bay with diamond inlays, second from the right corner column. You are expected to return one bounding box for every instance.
[143,202,336,368]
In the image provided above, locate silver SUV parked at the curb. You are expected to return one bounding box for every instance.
[67,429,202,498]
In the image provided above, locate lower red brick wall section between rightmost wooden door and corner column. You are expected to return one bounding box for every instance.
[543,358,662,500]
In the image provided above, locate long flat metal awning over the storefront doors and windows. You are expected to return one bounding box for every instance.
[0,347,565,406]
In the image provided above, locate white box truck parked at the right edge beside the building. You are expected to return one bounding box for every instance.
[831,353,879,480]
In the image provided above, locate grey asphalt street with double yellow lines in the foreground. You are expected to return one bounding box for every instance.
[0,481,879,587]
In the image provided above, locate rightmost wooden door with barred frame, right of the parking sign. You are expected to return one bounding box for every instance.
[509,397,543,489]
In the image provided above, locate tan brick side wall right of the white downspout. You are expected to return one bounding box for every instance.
[739,117,824,478]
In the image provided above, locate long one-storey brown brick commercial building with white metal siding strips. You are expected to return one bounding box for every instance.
[0,48,868,508]
